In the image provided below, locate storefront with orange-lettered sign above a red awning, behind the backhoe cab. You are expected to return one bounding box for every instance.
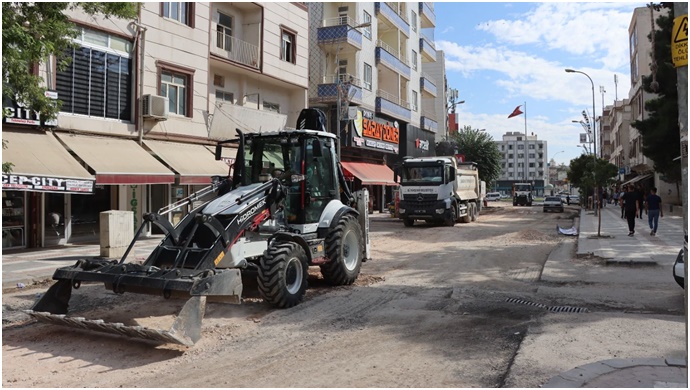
[341,108,400,211]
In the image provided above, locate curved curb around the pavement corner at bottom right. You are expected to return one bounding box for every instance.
[541,358,687,388]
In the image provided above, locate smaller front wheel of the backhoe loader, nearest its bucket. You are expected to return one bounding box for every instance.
[256,241,309,308]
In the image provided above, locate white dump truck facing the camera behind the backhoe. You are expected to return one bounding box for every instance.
[395,156,481,227]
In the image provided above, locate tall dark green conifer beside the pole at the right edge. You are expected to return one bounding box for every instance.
[632,3,682,184]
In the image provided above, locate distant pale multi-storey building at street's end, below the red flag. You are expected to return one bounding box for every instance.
[495,131,549,195]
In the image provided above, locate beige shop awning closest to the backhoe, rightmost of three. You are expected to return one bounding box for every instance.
[144,140,229,184]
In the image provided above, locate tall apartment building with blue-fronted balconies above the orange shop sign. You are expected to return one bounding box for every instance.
[307,2,444,210]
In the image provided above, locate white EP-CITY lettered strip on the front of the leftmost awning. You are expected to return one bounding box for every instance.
[2,174,94,194]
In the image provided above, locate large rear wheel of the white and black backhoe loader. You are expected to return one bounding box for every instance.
[321,215,364,286]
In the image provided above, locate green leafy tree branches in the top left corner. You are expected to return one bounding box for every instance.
[2,2,139,119]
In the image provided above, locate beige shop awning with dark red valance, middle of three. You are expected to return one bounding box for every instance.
[58,134,175,185]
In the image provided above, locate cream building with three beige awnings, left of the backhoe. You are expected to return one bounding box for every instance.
[3,2,309,249]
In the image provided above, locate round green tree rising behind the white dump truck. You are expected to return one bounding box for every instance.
[444,126,501,187]
